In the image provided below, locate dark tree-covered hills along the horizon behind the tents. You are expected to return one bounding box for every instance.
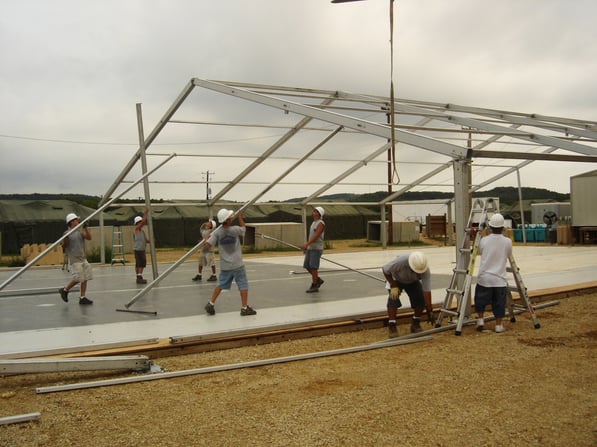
[0,186,570,209]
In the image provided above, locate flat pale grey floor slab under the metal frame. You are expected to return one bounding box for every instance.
[0,245,597,358]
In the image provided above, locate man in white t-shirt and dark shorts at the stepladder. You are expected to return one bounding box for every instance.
[475,213,512,333]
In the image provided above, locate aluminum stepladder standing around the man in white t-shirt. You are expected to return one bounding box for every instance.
[435,198,540,335]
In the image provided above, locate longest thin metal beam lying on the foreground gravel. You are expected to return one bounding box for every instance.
[35,336,432,394]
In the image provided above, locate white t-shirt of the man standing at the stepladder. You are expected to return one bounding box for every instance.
[477,233,512,287]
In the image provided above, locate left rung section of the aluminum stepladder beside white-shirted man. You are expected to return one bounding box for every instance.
[435,198,498,335]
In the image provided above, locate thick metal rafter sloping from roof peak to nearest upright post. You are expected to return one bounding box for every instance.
[192,78,467,158]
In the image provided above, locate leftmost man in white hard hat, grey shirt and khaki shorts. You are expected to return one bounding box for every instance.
[58,213,93,305]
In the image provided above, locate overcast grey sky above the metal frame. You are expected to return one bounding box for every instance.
[0,0,597,200]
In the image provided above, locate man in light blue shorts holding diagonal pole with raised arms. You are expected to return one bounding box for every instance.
[205,208,257,317]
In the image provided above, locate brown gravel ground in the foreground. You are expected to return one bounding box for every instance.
[0,294,597,447]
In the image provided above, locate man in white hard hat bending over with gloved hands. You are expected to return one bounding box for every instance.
[382,251,435,338]
